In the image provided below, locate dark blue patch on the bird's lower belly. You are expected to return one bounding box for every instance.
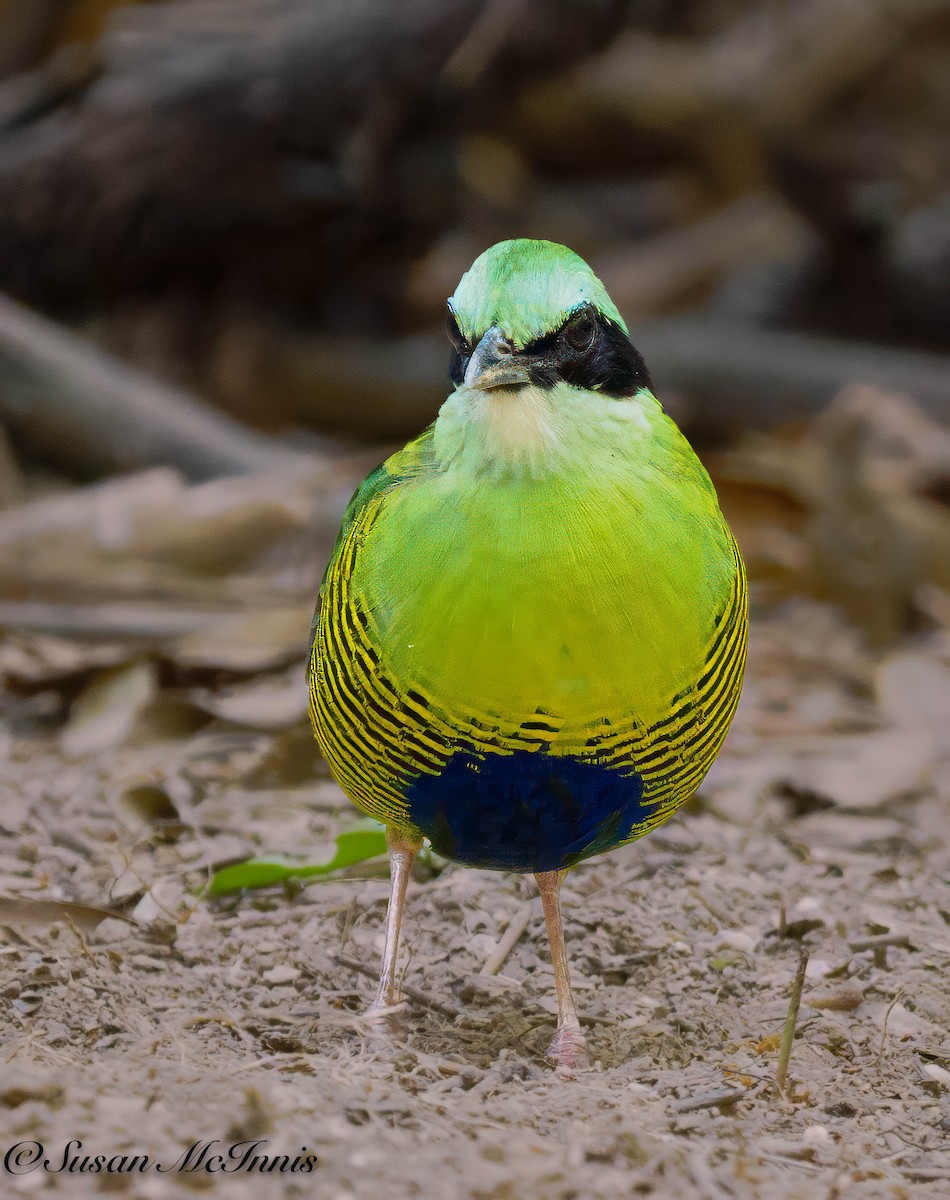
[405,750,655,871]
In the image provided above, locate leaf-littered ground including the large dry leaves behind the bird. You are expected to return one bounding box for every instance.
[0,390,950,1200]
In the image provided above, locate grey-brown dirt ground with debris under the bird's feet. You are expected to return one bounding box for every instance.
[0,601,950,1200]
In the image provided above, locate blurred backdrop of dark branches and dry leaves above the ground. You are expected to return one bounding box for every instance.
[0,0,950,748]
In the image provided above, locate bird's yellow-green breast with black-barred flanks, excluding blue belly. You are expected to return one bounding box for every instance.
[313,408,746,836]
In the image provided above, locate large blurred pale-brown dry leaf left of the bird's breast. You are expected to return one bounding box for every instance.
[0,458,340,619]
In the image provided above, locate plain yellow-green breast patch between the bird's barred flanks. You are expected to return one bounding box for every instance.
[351,453,735,730]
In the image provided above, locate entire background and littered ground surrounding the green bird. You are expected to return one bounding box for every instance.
[0,9,950,1176]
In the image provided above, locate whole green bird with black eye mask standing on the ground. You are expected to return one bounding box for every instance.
[309,240,747,1067]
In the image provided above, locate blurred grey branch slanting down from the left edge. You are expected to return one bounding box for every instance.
[0,296,318,479]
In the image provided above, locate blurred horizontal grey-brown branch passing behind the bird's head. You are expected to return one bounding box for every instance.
[278,319,950,437]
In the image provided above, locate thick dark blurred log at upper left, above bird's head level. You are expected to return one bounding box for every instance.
[0,0,625,313]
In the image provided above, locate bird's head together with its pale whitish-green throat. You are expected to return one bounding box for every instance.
[433,239,659,479]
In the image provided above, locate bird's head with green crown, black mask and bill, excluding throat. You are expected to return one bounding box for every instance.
[449,239,650,397]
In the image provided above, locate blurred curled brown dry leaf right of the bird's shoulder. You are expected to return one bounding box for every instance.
[718,385,950,646]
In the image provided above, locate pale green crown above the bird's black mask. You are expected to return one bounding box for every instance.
[449,238,627,347]
